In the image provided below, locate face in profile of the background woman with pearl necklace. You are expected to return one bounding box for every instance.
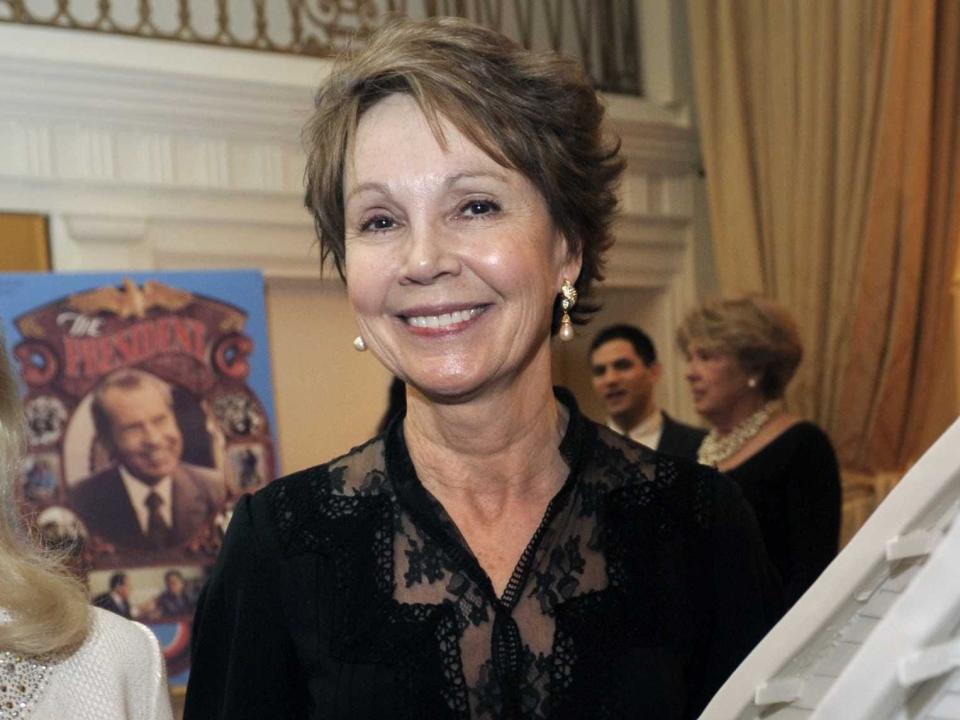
[686,341,759,421]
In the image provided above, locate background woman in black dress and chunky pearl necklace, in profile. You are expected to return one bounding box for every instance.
[677,298,841,611]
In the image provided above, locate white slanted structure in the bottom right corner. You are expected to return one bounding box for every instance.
[701,420,960,720]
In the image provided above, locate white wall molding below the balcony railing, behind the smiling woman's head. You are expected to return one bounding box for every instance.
[0,25,699,292]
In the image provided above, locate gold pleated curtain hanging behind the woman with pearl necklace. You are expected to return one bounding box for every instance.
[688,0,960,470]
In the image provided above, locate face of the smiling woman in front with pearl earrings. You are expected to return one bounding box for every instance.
[344,95,580,397]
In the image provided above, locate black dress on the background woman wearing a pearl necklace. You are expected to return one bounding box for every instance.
[727,422,841,610]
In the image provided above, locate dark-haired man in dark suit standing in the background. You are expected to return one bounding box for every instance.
[590,324,707,460]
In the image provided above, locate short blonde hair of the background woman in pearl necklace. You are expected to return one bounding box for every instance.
[677,297,803,400]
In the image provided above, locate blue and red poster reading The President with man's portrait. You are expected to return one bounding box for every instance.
[0,271,278,685]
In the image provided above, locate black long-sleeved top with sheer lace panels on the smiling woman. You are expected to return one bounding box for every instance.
[185,392,779,720]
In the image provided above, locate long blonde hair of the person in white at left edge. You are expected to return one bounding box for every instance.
[0,335,90,656]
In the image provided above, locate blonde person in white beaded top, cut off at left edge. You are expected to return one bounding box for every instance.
[0,337,172,720]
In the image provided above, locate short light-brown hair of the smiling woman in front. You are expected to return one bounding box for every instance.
[304,18,624,322]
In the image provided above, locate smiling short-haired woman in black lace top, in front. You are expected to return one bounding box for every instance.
[186,19,776,720]
